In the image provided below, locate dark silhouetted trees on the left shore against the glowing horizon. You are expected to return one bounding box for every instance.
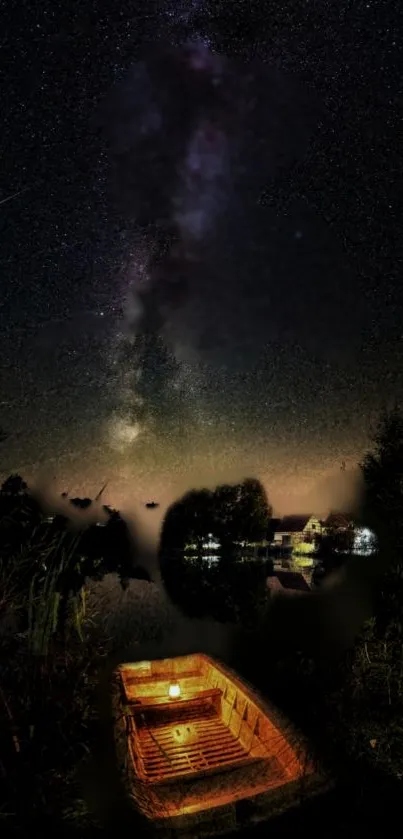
[0,475,150,637]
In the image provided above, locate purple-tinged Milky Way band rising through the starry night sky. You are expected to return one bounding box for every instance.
[104,40,243,445]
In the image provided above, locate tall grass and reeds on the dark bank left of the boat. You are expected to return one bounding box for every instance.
[0,496,110,834]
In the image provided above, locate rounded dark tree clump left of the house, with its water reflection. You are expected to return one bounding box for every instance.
[160,479,271,621]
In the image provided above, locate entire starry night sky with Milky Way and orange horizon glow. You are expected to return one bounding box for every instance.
[0,0,403,512]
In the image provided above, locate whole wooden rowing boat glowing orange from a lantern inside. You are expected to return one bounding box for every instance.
[113,654,328,836]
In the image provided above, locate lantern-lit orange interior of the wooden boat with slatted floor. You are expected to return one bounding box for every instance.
[120,654,310,812]
